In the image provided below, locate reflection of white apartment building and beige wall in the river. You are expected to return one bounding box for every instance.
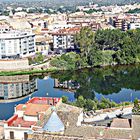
[0,75,37,100]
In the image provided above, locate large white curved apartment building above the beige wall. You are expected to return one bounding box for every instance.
[0,29,35,59]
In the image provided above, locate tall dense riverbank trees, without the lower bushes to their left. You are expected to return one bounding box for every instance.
[75,28,140,66]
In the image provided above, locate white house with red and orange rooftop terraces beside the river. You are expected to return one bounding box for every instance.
[4,97,61,140]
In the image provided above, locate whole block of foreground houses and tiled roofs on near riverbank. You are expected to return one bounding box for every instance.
[4,97,140,140]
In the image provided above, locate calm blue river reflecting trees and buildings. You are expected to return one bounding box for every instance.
[0,65,140,120]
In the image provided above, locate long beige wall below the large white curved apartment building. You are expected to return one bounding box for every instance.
[0,59,29,71]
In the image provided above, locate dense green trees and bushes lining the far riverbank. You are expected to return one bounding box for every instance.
[51,27,140,69]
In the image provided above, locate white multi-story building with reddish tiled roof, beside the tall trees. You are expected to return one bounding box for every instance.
[52,27,80,53]
